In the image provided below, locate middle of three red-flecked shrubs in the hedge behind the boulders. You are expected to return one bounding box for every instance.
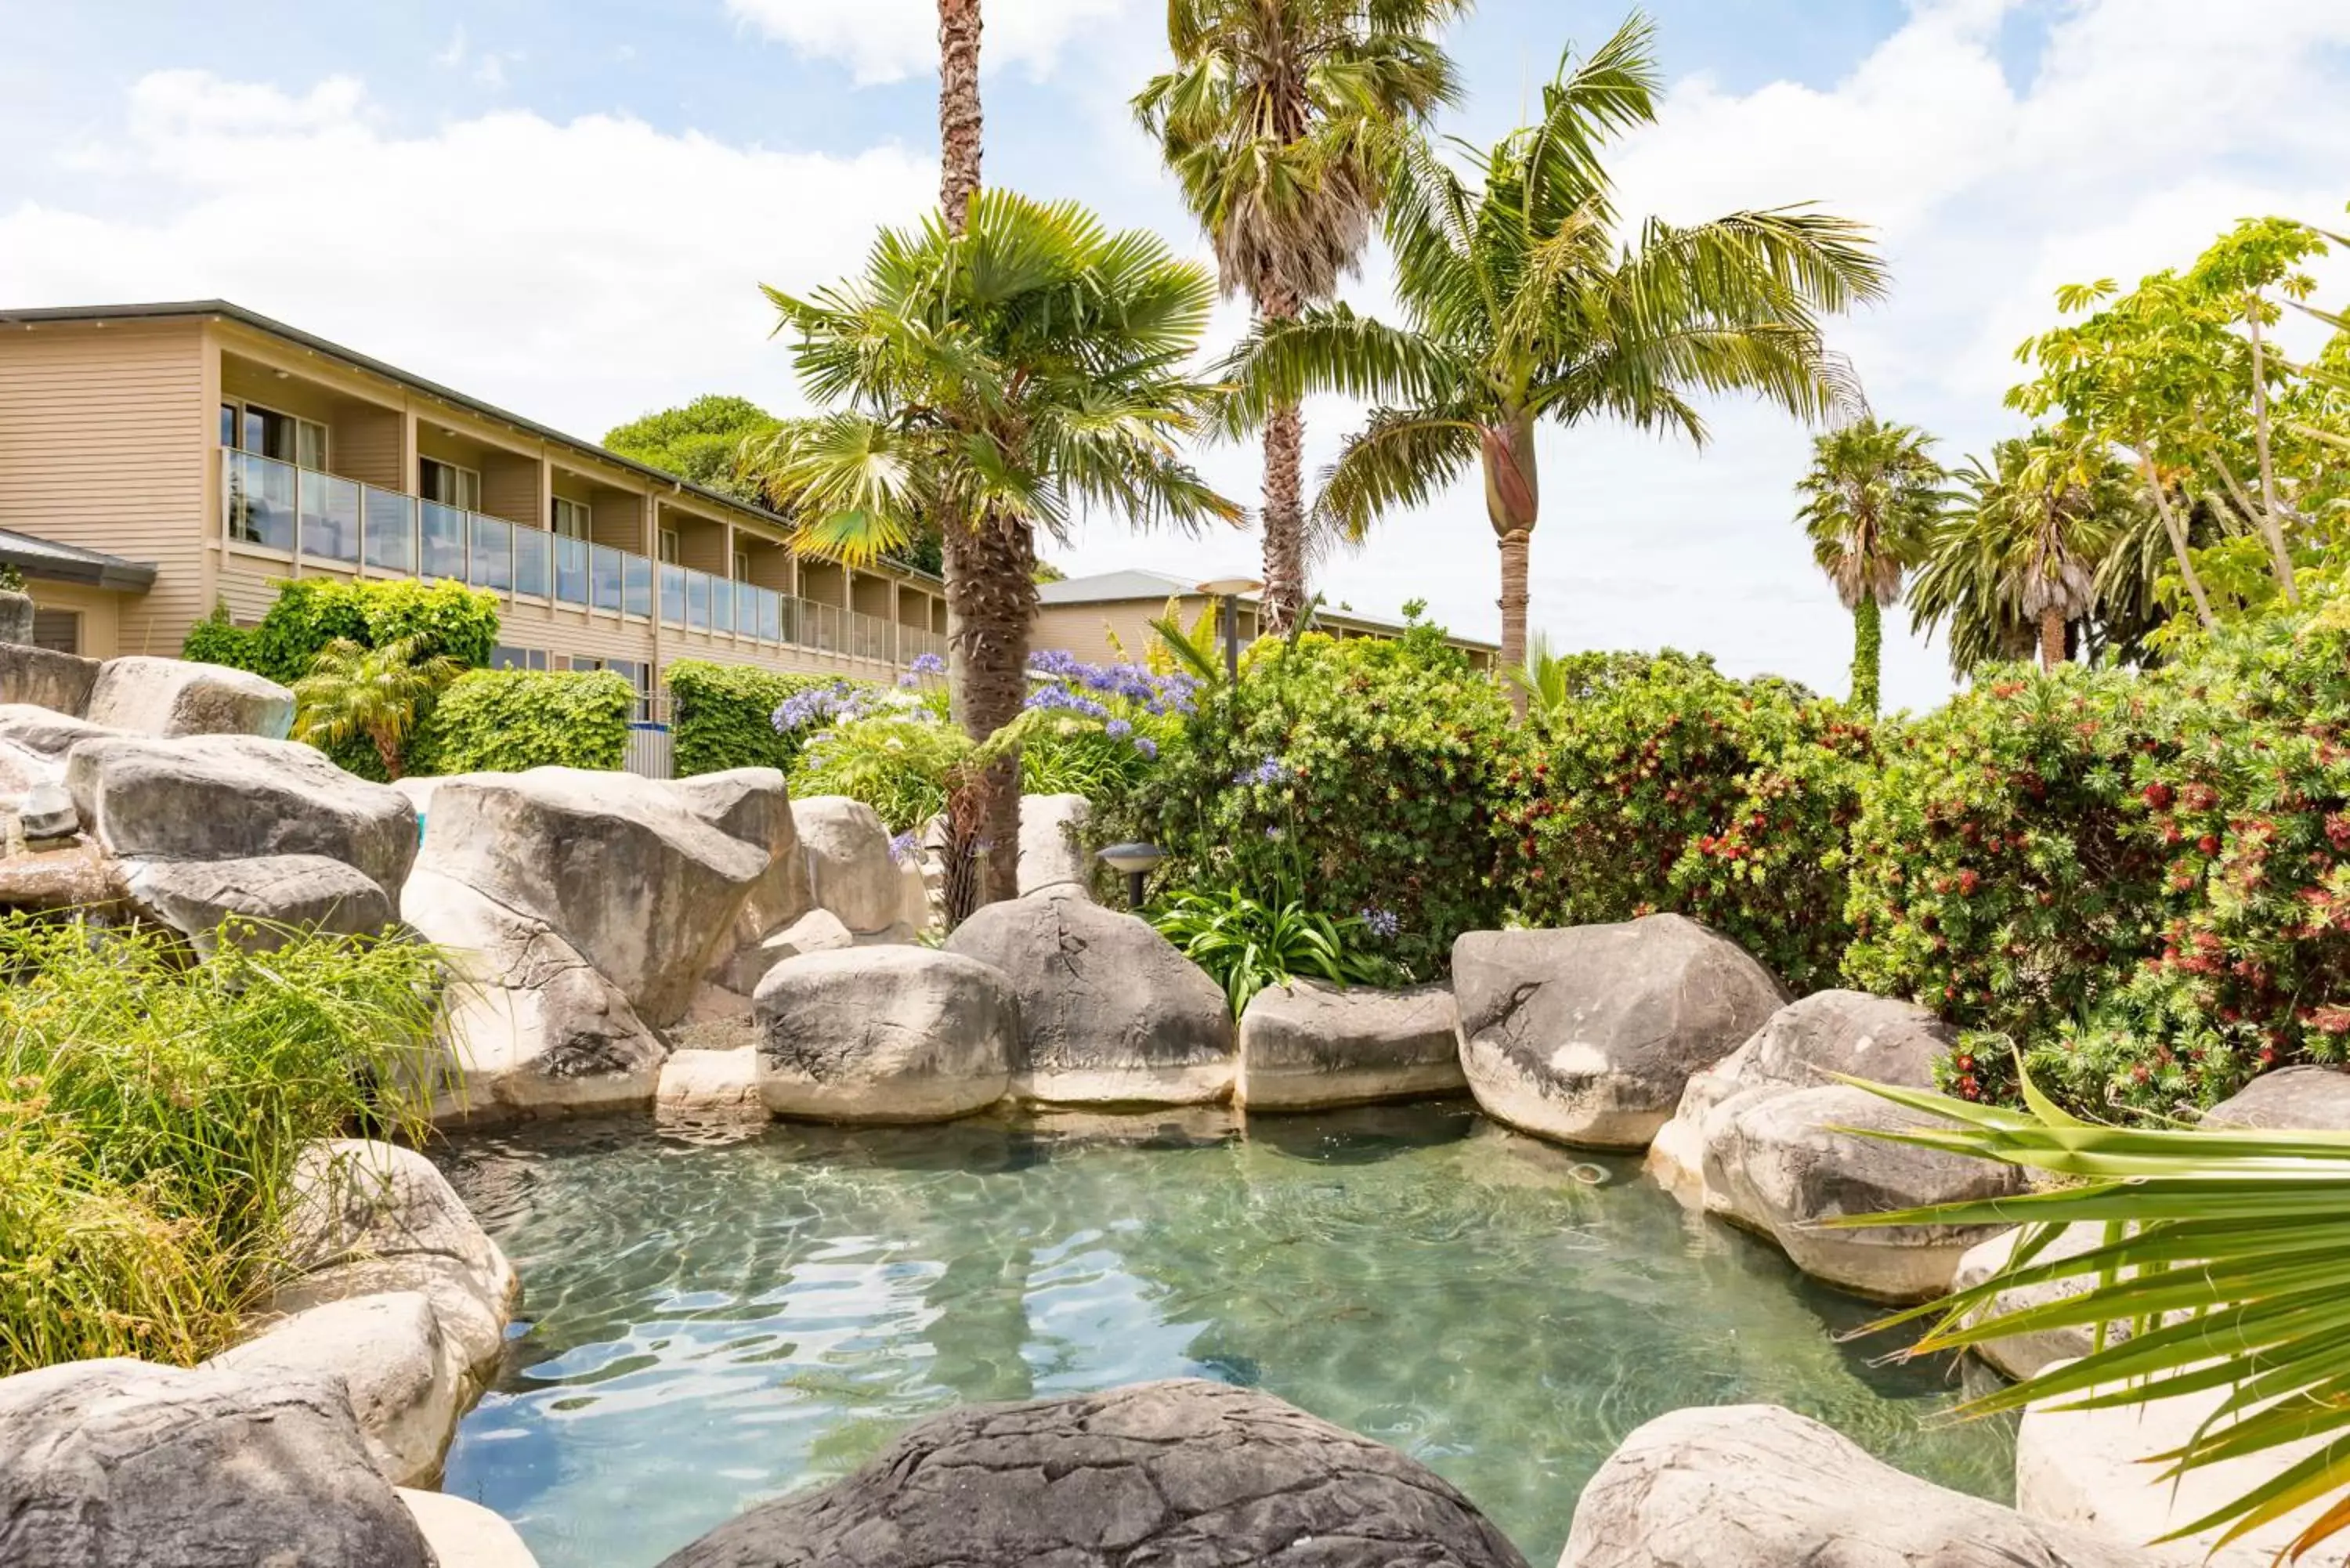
[1499,651,1871,992]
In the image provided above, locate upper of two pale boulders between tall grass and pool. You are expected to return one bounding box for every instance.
[270,1138,522,1387]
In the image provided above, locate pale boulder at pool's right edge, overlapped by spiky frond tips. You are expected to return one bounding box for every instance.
[1706,1084,2026,1302]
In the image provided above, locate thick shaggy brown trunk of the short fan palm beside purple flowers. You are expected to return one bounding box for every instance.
[945,515,1036,924]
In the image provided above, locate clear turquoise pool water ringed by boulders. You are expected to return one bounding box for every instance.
[446,1105,2014,1568]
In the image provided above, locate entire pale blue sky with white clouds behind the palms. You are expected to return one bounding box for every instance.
[0,0,2350,707]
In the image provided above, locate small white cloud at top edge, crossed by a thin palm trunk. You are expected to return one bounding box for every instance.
[726,0,1130,87]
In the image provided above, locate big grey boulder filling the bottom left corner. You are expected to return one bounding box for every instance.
[0,1361,432,1568]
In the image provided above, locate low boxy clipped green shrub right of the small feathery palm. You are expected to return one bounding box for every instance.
[411,670,637,773]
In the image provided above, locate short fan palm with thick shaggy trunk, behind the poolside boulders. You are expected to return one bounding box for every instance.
[754,190,1241,919]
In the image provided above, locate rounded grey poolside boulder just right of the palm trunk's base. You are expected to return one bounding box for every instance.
[947,889,1236,1105]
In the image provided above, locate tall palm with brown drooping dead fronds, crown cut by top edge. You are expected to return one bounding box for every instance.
[1135,0,1473,632]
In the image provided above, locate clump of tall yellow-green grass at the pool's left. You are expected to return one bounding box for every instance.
[0,915,442,1373]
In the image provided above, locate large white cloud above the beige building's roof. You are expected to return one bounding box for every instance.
[0,70,935,435]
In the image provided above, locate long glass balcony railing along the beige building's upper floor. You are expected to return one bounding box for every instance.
[221,446,916,663]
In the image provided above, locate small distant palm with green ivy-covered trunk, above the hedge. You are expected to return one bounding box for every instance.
[1795,414,1946,712]
